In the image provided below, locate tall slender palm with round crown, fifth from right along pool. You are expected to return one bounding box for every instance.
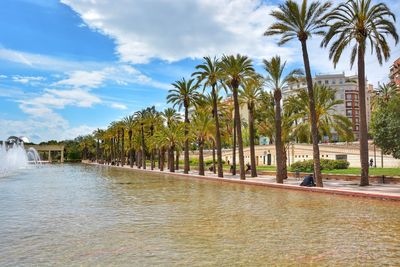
[220,54,254,180]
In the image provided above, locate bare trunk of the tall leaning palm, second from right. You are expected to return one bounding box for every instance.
[301,40,323,187]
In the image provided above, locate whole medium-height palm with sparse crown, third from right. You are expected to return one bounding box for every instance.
[264,56,302,183]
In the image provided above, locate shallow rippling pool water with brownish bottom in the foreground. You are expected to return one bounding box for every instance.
[0,165,400,266]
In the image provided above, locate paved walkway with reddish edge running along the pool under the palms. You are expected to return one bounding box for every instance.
[94,165,400,201]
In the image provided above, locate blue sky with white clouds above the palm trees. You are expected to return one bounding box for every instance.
[0,0,400,143]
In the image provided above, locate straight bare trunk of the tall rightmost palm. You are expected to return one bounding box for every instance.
[358,43,369,186]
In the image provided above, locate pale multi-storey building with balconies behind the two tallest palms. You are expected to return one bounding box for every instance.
[282,73,373,141]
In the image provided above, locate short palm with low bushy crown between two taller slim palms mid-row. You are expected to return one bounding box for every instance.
[192,108,216,175]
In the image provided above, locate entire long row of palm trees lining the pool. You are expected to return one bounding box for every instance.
[89,0,398,186]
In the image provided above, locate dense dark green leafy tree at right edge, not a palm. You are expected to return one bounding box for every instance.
[371,95,400,159]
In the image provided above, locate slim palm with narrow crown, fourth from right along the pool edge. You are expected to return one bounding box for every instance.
[239,75,264,177]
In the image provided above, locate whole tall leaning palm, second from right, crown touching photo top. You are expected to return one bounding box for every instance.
[264,0,331,187]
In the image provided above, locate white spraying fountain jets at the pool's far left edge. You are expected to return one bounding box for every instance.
[0,136,40,177]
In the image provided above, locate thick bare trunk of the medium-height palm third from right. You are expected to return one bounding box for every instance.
[274,89,284,184]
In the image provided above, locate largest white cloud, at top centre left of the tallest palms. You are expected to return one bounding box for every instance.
[62,0,293,63]
